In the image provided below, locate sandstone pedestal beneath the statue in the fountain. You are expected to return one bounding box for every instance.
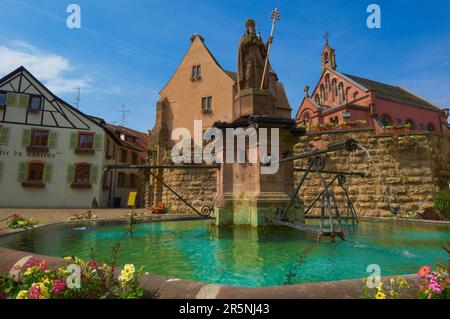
[214,89,304,227]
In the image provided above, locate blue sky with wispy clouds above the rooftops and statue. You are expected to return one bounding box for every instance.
[0,0,450,131]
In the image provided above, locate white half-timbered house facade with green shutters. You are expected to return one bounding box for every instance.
[0,67,142,208]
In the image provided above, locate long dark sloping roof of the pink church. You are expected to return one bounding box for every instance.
[344,74,439,110]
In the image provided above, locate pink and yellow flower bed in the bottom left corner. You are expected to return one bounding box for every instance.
[0,257,143,299]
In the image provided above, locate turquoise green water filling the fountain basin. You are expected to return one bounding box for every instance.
[0,220,450,287]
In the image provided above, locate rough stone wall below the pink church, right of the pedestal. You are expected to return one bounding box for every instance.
[294,129,450,216]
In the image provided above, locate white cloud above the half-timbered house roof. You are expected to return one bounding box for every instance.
[0,40,91,94]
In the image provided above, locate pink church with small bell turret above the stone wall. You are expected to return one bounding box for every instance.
[296,39,448,133]
